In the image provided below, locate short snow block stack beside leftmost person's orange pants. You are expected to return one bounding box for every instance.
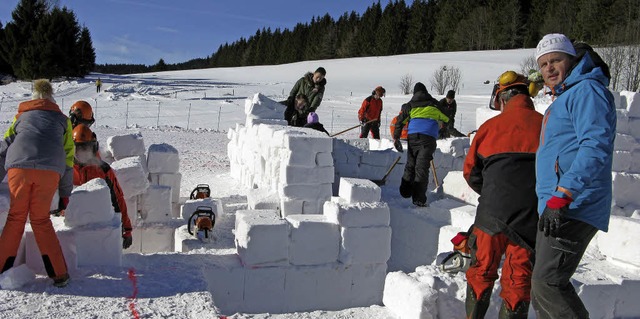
[24,178,122,274]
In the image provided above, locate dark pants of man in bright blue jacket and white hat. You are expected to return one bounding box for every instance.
[531,219,598,318]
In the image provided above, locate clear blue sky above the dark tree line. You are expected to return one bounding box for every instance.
[0,0,390,64]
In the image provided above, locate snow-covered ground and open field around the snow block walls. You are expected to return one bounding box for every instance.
[0,50,628,318]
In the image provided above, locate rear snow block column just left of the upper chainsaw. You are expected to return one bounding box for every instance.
[147,143,182,217]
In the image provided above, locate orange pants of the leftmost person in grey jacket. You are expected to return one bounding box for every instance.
[0,168,67,278]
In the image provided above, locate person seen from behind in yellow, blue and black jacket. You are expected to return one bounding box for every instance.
[393,82,449,207]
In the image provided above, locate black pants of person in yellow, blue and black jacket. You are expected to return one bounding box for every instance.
[400,134,436,204]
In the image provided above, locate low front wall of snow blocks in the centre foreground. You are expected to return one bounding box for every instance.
[205,179,391,314]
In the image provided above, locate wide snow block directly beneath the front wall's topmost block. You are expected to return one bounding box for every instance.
[323,201,391,227]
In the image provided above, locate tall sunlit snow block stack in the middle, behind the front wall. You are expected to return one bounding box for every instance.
[227,94,334,216]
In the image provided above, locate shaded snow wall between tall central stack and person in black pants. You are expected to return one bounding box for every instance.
[332,138,406,195]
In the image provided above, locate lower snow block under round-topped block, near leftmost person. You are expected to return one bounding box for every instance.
[73,214,122,267]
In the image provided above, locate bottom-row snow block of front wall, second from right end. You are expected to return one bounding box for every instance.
[284,263,353,312]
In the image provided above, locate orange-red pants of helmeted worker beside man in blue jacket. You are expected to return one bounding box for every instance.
[466,225,535,310]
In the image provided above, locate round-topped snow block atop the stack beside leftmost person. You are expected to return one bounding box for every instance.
[64,178,114,227]
